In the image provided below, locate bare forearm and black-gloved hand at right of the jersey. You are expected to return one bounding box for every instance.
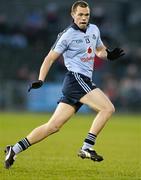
[96,45,125,61]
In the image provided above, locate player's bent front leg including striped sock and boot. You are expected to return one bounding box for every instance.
[78,88,115,161]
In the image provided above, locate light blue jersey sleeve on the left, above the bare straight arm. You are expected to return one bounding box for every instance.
[52,33,68,54]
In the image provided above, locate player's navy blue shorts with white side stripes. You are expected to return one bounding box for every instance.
[58,71,96,111]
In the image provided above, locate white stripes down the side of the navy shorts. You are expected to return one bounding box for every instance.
[73,72,91,93]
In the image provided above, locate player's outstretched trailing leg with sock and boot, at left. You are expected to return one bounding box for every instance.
[5,102,75,169]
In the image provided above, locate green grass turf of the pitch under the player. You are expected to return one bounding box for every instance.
[0,113,141,180]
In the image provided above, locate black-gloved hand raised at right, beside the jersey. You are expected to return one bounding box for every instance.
[106,48,125,61]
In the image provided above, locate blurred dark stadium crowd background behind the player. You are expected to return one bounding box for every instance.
[0,0,141,112]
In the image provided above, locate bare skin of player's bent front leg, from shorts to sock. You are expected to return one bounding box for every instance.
[80,88,115,135]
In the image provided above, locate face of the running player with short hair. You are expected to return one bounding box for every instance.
[71,6,90,29]
